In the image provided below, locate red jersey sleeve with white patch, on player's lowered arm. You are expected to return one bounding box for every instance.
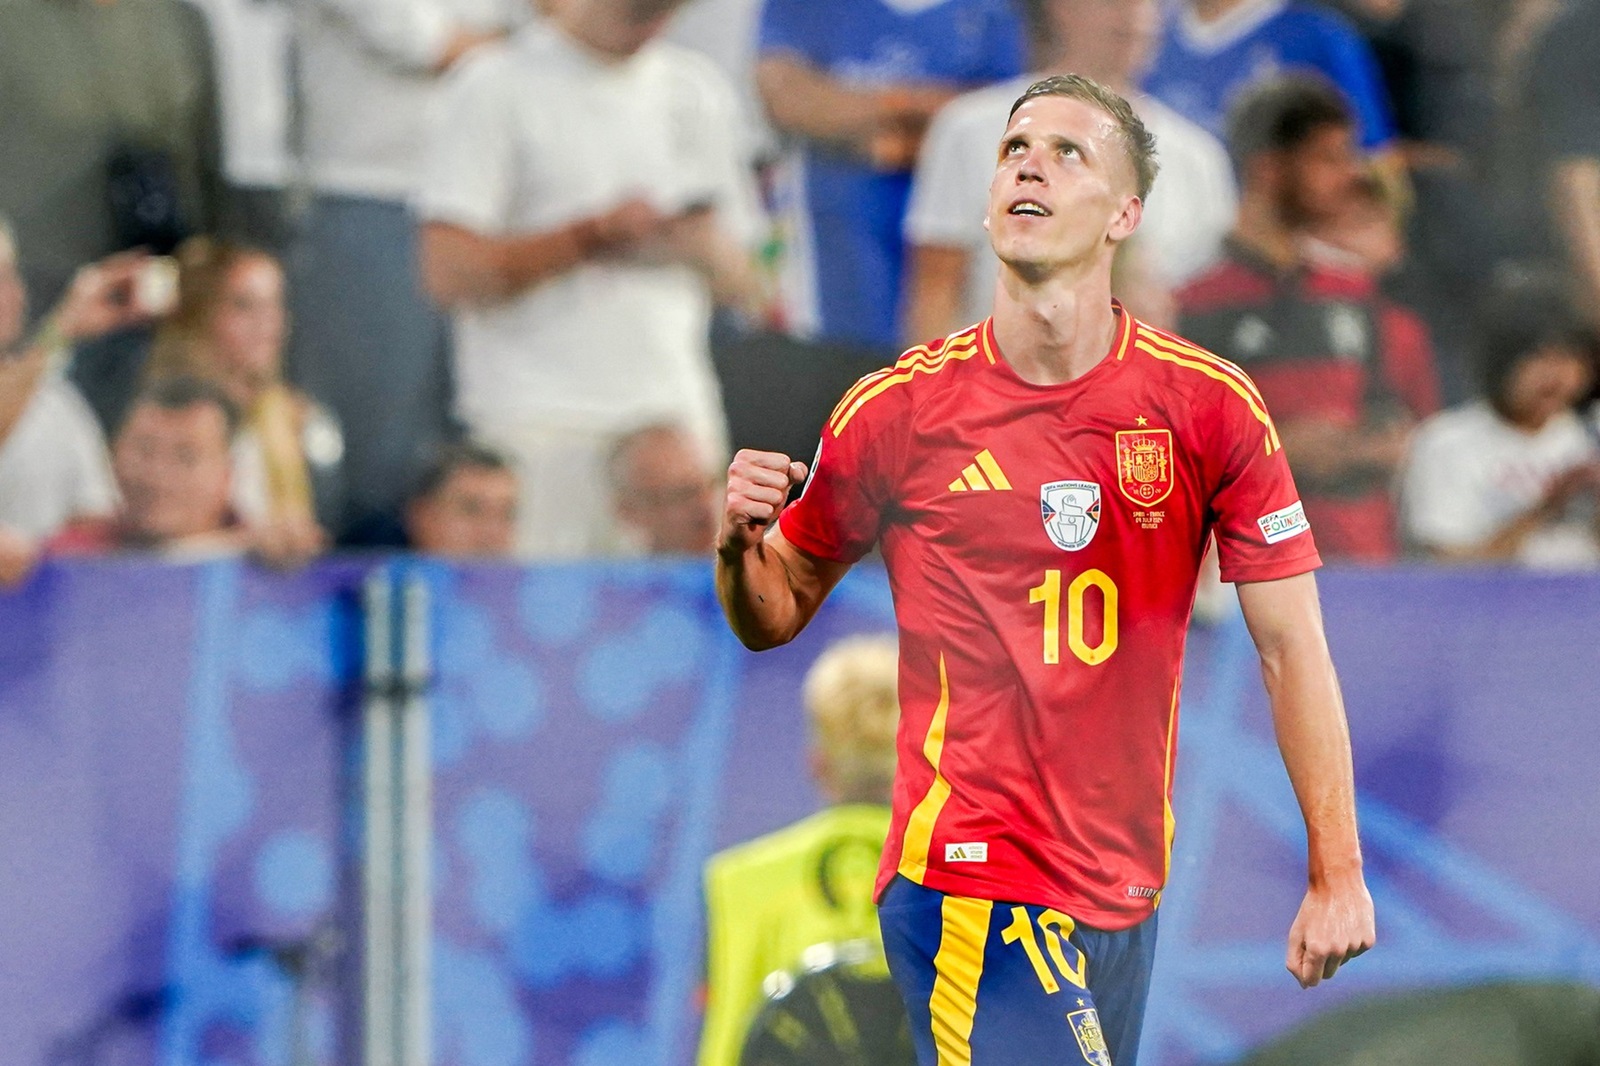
[1211,384,1322,581]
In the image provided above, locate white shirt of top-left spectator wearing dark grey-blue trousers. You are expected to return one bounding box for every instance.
[299,0,533,200]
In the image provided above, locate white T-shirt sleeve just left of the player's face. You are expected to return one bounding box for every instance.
[906,98,1000,250]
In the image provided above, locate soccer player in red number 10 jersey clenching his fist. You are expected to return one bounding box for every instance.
[717,75,1374,1066]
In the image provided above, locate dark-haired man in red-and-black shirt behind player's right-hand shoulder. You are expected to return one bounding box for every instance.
[1179,77,1438,562]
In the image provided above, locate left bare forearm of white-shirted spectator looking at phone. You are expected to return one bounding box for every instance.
[422,221,595,307]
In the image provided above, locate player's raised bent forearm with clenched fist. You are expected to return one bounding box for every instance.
[717,450,850,651]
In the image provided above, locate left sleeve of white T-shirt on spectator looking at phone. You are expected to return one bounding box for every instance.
[418,50,517,234]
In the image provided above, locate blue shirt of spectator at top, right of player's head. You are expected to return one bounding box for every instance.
[1144,0,1395,152]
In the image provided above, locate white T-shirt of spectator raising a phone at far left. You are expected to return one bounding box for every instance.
[0,378,117,539]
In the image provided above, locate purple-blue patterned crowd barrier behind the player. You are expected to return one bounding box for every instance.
[0,560,1600,1066]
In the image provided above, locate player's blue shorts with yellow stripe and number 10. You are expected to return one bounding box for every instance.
[878,877,1155,1066]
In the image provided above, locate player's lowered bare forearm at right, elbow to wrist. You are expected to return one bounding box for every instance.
[1261,626,1362,885]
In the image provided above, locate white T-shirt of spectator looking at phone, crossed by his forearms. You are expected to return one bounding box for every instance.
[421,24,757,439]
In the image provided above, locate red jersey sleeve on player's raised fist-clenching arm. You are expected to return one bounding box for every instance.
[778,382,906,563]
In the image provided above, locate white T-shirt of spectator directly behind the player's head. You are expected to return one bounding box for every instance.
[906,77,1238,322]
